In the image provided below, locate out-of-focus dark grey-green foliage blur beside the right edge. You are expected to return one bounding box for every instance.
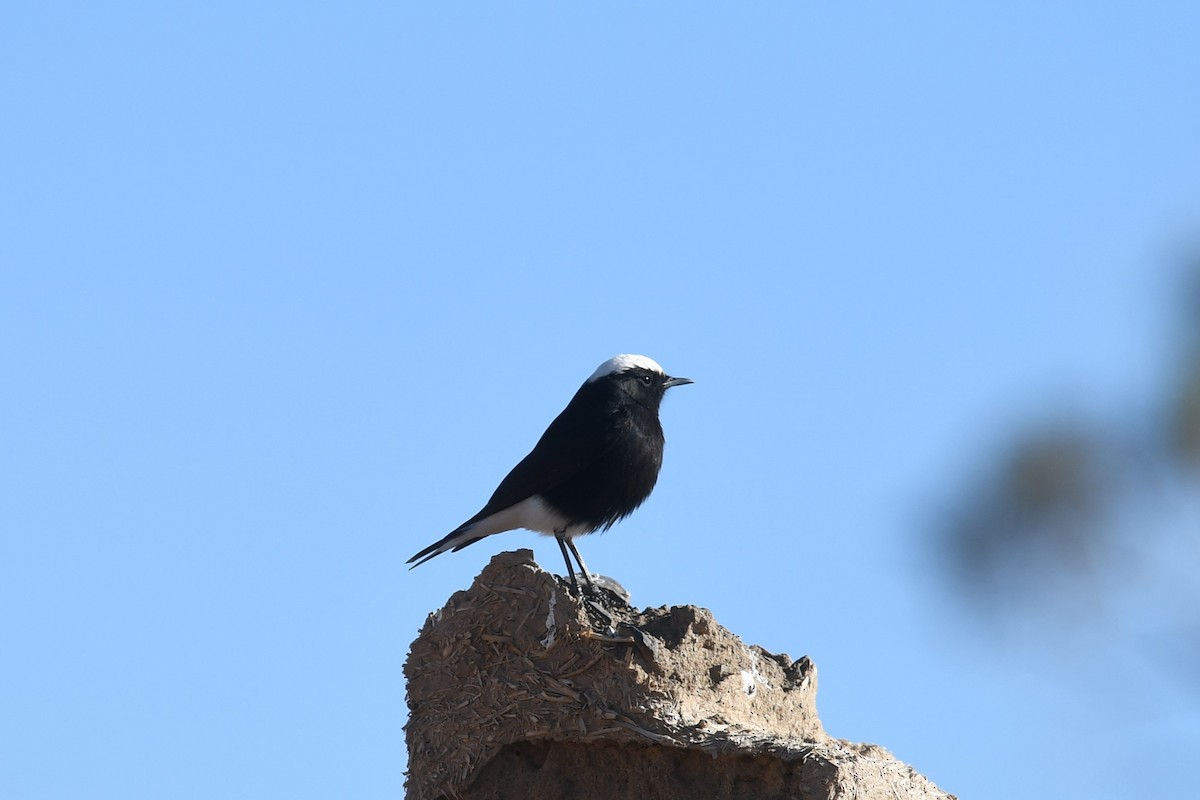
[938,261,1200,678]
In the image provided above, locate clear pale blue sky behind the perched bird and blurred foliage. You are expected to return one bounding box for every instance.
[0,2,1200,799]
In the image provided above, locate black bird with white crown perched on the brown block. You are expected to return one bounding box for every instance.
[407,354,694,594]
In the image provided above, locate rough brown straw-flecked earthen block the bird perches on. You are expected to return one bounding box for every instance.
[404,549,949,800]
